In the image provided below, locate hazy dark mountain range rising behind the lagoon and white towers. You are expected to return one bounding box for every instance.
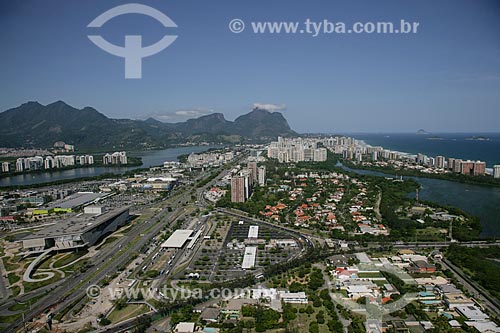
[0,101,297,150]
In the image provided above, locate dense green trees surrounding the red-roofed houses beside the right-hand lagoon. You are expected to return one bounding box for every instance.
[217,153,481,241]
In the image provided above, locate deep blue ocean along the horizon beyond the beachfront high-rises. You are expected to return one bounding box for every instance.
[346,133,500,168]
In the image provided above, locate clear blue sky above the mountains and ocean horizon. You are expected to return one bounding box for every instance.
[0,0,500,132]
